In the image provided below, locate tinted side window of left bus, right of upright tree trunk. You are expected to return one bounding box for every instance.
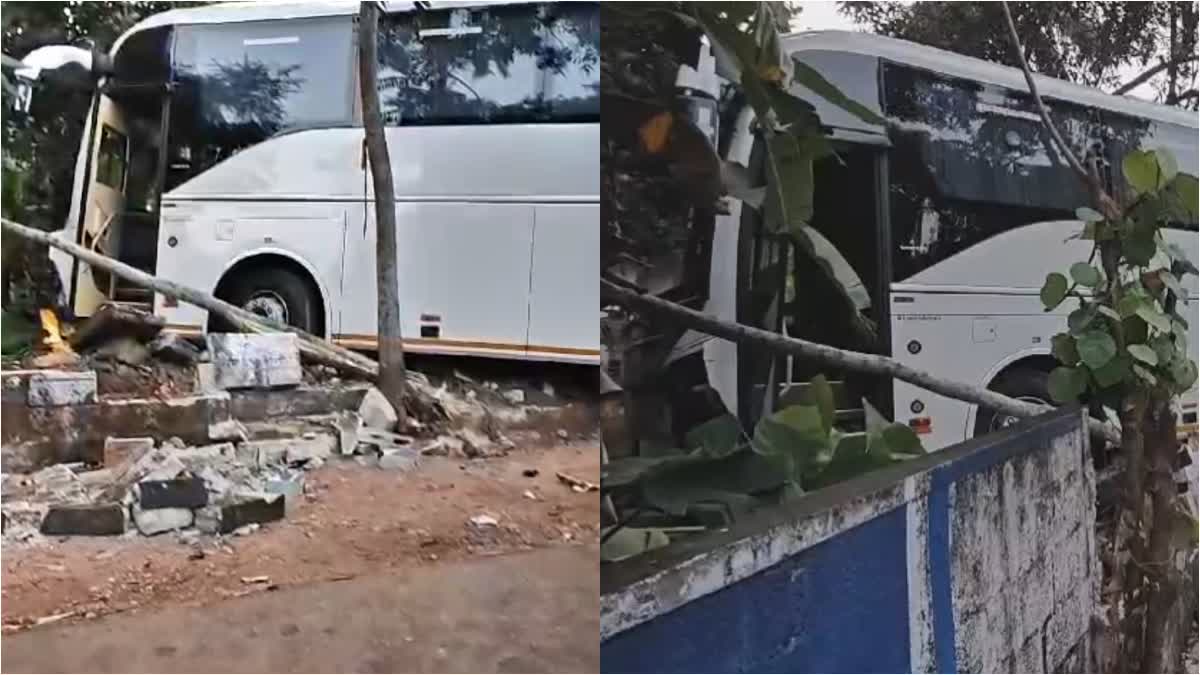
[378,4,600,125]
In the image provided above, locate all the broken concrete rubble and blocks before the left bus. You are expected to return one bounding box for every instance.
[0,307,585,545]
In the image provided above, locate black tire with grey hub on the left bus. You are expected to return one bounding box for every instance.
[222,267,322,335]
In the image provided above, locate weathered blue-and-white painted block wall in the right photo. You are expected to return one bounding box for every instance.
[601,403,1099,673]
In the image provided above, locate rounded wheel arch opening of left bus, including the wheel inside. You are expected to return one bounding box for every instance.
[209,252,329,336]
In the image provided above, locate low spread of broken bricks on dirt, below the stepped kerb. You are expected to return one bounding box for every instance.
[0,401,420,543]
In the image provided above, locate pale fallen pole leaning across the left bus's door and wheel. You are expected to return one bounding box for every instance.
[0,219,379,380]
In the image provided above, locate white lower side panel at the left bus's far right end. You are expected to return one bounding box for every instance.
[528,204,600,360]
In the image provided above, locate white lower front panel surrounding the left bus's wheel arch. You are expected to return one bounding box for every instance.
[155,199,347,331]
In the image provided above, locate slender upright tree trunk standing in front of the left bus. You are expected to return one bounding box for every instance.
[359,2,407,430]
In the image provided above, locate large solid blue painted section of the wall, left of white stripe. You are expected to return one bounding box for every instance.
[600,508,908,673]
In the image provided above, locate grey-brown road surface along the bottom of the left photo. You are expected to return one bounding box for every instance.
[2,545,600,673]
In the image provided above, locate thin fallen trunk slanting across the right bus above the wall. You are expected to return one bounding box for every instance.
[600,279,1120,443]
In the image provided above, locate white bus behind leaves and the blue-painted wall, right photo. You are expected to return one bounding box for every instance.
[672,31,1198,449]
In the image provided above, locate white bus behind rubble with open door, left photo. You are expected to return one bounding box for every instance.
[37,2,600,364]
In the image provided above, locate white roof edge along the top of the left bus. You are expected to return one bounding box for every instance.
[113,0,525,54]
